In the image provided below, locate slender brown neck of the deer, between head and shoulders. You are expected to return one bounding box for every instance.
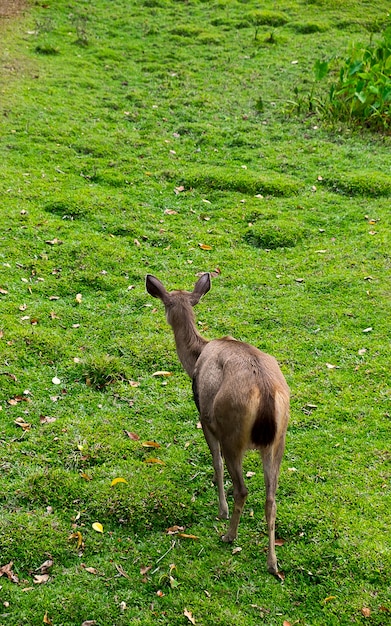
[170,311,208,378]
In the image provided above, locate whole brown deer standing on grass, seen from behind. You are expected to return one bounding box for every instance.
[146,272,289,576]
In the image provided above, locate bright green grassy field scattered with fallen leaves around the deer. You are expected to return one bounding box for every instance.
[0,0,391,626]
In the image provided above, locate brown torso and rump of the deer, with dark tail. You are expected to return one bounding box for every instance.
[193,338,289,447]
